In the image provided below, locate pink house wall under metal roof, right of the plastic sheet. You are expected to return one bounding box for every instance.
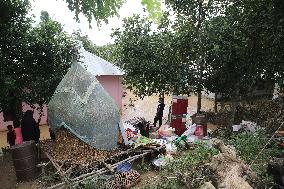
[96,75,123,110]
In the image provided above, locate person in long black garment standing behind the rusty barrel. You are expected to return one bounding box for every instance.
[21,110,40,143]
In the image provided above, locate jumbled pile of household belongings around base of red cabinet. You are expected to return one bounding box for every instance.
[123,117,209,167]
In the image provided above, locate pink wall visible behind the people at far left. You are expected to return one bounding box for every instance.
[0,102,47,131]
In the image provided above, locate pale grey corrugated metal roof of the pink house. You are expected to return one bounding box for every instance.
[79,47,123,76]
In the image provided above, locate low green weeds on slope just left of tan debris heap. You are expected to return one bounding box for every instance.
[143,142,219,189]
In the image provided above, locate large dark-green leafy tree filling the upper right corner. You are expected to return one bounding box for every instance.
[202,0,284,127]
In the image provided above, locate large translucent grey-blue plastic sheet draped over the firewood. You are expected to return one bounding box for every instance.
[48,63,120,150]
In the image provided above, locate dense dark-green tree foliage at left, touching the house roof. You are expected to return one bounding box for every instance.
[0,0,77,124]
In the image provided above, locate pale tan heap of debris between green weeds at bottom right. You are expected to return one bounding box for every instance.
[201,139,264,189]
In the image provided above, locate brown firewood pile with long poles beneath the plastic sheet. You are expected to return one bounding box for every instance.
[41,129,163,189]
